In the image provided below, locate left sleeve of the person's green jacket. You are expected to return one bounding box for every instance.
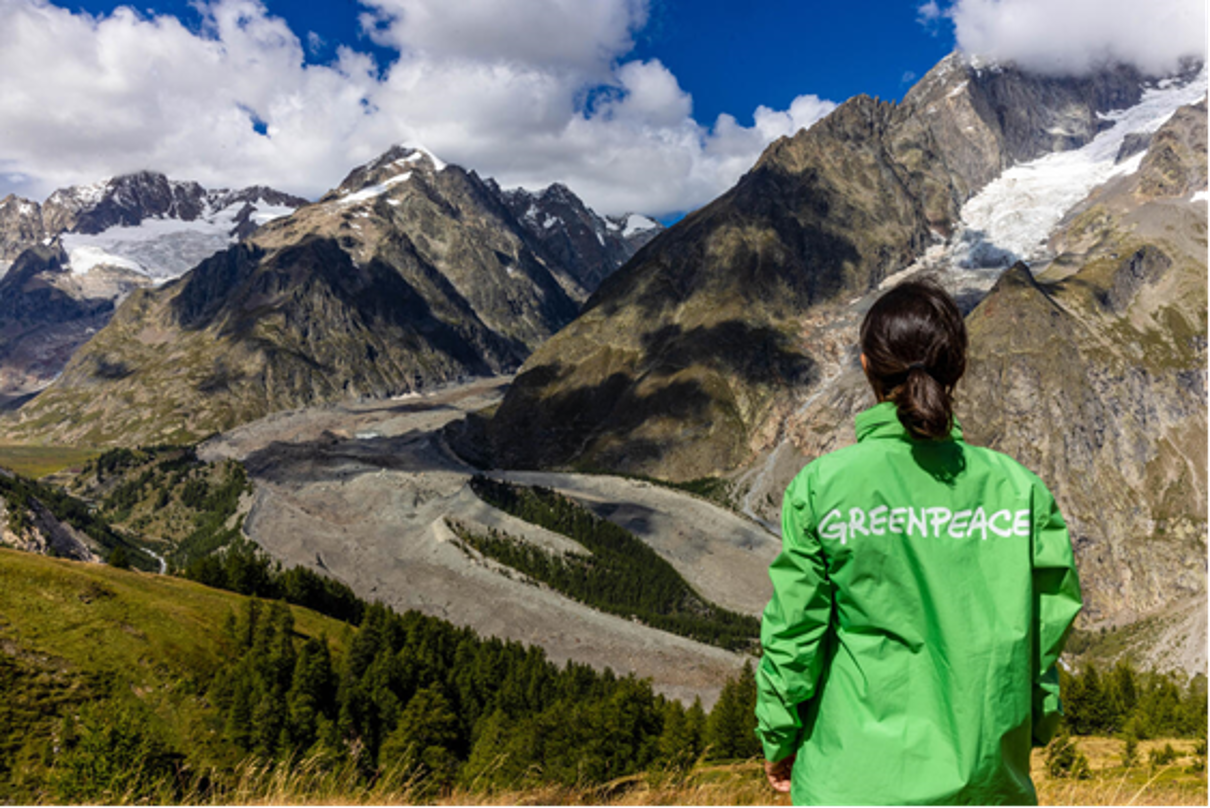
[756,480,832,762]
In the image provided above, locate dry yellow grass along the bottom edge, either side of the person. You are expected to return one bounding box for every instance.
[47,739,1210,808]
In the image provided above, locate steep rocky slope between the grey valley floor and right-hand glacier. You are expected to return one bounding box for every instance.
[490,56,1143,479]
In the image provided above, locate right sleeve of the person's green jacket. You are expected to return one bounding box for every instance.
[1033,483,1083,746]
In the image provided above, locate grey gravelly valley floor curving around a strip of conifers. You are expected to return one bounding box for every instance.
[198,380,780,706]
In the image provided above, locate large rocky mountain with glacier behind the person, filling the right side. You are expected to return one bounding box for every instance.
[484,56,1210,673]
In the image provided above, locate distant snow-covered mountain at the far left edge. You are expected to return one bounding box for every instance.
[0,172,306,404]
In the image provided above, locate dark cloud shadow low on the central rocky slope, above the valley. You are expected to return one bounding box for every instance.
[486,321,816,471]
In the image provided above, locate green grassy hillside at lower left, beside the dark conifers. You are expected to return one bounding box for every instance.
[0,549,348,803]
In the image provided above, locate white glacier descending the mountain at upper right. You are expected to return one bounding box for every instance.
[953,67,1210,270]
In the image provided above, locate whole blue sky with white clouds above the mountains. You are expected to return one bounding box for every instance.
[0,0,1210,220]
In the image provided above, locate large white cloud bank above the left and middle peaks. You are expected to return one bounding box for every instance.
[0,0,834,215]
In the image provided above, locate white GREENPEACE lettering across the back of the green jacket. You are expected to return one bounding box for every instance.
[817,506,1030,544]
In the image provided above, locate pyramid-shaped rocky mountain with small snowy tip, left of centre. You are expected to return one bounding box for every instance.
[4,146,658,443]
